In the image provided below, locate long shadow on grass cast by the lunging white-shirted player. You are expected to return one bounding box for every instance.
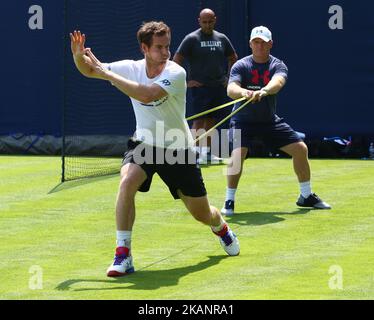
[56,255,228,291]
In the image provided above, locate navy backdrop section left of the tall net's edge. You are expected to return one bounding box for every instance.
[0,0,64,135]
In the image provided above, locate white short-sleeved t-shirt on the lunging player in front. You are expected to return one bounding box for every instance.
[104,59,193,149]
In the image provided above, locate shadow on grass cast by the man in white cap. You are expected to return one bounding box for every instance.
[225,208,314,226]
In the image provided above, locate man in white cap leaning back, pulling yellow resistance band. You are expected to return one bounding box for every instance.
[222,26,331,215]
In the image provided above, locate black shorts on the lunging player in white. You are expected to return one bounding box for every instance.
[122,139,207,199]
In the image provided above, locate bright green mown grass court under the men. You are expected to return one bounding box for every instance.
[0,156,374,300]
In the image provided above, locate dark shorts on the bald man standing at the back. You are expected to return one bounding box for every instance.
[191,85,231,120]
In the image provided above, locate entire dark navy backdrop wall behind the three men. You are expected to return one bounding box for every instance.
[0,0,374,144]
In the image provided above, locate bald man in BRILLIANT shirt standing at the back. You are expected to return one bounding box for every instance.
[173,9,238,163]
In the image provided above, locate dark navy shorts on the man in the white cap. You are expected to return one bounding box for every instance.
[229,119,303,149]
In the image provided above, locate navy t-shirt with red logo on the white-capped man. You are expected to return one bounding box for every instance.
[229,55,288,123]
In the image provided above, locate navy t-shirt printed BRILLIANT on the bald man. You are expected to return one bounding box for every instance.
[176,29,235,87]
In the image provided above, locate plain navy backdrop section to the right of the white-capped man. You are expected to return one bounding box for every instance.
[249,0,374,137]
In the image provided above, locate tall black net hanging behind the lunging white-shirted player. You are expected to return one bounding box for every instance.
[62,0,243,181]
